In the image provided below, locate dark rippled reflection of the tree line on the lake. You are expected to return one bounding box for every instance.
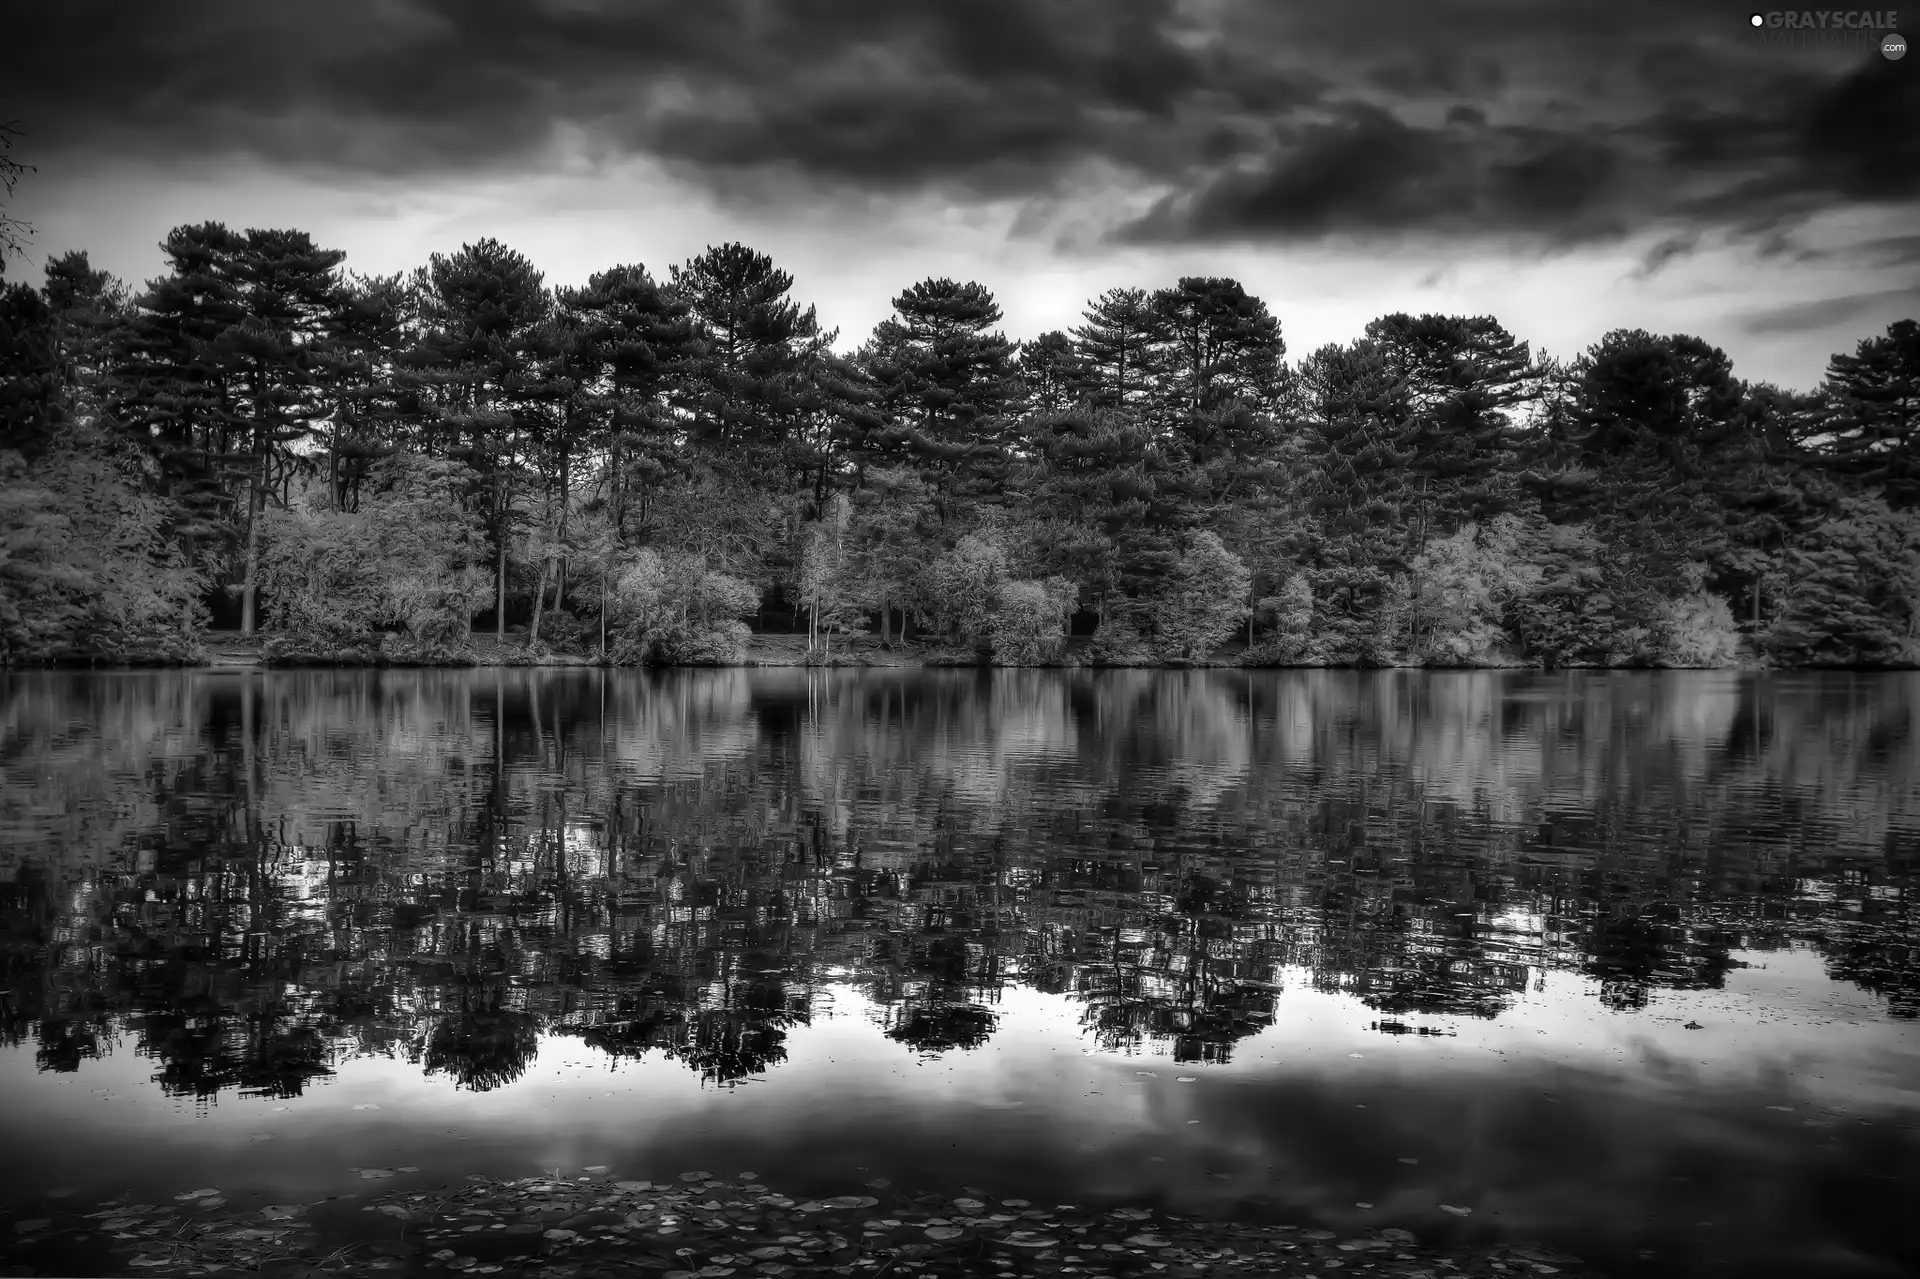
[0,656,1920,1098]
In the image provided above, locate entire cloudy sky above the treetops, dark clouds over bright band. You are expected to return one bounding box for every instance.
[0,0,1920,388]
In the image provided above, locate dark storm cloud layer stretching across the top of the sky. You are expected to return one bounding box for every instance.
[0,0,1920,244]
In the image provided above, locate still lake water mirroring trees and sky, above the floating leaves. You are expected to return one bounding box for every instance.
[0,670,1920,1275]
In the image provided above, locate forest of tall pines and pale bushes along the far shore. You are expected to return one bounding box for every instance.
[0,223,1920,668]
